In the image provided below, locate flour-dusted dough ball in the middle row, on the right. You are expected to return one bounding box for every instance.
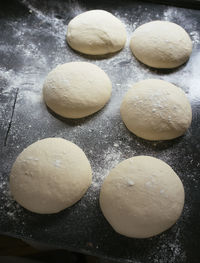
[120,79,192,140]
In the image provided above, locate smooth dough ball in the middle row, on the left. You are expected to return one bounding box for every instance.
[43,62,112,118]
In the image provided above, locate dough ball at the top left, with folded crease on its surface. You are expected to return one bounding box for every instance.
[67,10,126,55]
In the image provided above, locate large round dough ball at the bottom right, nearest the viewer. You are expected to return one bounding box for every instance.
[100,156,184,238]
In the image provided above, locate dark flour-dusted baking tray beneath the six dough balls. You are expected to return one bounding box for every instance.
[0,0,200,263]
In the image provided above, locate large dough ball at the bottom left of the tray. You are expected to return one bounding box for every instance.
[10,138,92,214]
